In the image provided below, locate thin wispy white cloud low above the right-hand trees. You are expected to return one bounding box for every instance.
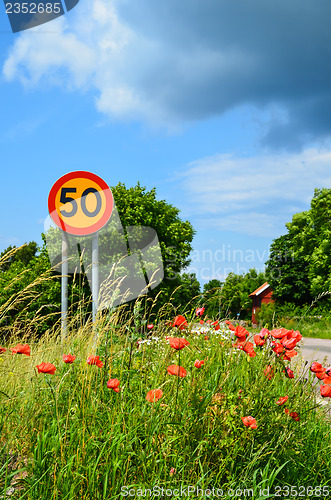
[179,149,331,238]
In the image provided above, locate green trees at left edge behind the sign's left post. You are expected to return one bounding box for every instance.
[0,240,91,334]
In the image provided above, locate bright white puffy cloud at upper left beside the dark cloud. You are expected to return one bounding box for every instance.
[3,0,163,119]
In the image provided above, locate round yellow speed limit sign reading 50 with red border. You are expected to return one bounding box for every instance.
[48,171,114,236]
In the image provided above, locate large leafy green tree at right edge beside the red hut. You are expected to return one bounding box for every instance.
[266,188,331,305]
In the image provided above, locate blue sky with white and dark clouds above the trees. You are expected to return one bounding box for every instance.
[0,0,331,283]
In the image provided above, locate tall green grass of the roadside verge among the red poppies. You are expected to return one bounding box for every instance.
[0,274,331,500]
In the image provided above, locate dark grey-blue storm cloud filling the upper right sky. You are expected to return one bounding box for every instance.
[118,0,331,148]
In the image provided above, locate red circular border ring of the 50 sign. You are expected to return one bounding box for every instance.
[48,170,114,236]
